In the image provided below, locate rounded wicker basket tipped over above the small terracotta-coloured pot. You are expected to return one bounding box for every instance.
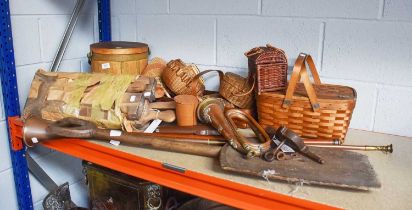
[162,59,205,95]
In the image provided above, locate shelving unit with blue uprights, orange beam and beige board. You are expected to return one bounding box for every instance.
[4,0,412,209]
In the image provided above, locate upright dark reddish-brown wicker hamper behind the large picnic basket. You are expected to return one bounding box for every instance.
[245,44,288,94]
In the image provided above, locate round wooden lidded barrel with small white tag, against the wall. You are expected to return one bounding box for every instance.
[90,41,149,75]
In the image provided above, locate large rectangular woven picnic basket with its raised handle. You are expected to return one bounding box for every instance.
[257,53,356,141]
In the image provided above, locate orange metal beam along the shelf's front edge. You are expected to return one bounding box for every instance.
[39,139,336,209]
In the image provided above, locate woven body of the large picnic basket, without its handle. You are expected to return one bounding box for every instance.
[257,84,356,140]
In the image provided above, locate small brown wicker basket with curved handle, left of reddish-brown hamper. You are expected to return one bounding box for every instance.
[193,70,255,109]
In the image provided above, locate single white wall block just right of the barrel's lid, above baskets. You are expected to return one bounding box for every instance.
[137,15,216,64]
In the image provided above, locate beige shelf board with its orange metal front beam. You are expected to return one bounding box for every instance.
[39,130,412,209]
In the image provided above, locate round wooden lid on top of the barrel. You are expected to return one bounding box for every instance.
[90,41,149,54]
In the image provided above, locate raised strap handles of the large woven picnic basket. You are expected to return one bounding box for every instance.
[282,53,321,111]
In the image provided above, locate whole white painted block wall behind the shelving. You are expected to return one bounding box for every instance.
[0,0,412,209]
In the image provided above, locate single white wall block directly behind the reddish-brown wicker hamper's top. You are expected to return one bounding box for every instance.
[217,17,323,68]
